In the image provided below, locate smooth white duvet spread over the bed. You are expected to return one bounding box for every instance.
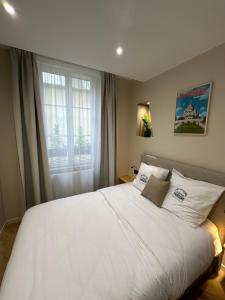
[0,184,214,300]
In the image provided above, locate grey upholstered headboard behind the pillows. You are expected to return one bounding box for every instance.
[141,154,225,243]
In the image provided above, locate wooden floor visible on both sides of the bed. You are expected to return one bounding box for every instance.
[0,223,225,300]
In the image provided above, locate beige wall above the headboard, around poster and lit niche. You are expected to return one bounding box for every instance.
[129,44,225,172]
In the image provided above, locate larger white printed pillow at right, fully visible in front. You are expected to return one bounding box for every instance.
[162,169,225,227]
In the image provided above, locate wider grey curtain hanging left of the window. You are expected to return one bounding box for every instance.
[11,49,51,208]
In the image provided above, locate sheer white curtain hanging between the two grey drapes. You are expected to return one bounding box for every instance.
[38,57,101,199]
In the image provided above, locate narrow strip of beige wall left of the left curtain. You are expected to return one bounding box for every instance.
[0,48,22,220]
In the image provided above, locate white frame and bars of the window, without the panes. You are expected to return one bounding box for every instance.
[38,59,101,174]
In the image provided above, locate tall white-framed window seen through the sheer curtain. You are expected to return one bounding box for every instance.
[39,63,100,174]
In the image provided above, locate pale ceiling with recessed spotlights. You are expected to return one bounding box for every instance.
[0,0,225,81]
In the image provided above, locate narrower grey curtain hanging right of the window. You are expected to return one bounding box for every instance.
[100,73,116,187]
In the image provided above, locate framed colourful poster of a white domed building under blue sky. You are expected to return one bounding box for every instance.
[174,82,212,135]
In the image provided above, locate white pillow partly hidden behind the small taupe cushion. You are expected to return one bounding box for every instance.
[133,162,169,191]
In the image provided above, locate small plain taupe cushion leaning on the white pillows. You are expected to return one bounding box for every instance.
[141,175,170,207]
